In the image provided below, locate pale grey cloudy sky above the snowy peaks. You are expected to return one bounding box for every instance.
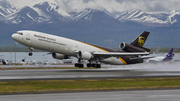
[7,0,180,12]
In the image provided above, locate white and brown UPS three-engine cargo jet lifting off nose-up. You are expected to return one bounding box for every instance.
[12,30,150,68]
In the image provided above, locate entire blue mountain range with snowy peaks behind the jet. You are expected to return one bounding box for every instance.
[0,0,180,48]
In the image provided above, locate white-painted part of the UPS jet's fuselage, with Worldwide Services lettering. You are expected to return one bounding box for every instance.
[12,30,127,65]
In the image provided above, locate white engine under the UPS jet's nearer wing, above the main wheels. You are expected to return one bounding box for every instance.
[77,51,93,60]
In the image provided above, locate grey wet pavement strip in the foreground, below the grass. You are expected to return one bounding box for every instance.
[0,90,180,101]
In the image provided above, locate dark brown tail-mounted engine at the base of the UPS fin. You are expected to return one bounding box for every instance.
[119,42,150,52]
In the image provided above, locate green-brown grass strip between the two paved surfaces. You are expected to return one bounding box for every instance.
[0,77,180,94]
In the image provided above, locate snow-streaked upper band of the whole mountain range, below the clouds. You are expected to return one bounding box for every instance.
[0,0,180,26]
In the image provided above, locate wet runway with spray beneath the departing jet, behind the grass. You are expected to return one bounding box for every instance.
[0,64,180,81]
